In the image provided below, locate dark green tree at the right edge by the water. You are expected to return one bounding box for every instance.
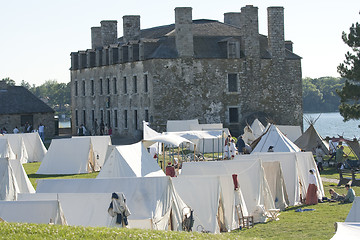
[336,15,360,121]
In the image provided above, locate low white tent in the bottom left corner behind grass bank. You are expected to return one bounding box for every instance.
[0,200,66,225]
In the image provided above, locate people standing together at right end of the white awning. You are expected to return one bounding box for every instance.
[224,135,252,159]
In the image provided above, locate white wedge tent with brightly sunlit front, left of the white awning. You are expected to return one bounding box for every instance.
[97,142,165,178]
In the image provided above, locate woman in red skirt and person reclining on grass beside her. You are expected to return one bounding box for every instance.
[305,169,355,205]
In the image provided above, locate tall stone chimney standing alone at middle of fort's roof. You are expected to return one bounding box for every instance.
[175,7,194,57]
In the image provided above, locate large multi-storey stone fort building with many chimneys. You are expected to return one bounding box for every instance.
[71,5,303,137]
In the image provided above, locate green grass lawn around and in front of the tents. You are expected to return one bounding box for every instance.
[7,163,360,239]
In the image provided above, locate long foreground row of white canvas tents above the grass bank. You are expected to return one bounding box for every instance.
[0,151,324,233]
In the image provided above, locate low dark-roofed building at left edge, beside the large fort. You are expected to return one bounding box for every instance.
[0,81,55,138]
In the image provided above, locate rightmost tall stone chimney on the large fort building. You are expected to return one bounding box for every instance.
[267,7,285,59]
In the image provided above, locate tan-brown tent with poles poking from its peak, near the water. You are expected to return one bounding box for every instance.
[294,124,329,154]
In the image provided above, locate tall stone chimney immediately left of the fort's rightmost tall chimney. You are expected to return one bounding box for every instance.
[240,5,260,58]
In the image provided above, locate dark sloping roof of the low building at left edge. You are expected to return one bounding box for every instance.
[0,85,55,114]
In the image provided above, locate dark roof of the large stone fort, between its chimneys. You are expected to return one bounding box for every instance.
[118,19,301,59]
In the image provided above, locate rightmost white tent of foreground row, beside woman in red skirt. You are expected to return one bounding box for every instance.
[233,152,325,206]
